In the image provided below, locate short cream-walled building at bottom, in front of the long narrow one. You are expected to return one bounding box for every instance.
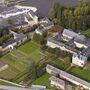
[49,76,65,90]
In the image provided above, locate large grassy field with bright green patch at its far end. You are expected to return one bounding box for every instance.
[0,41,43,81]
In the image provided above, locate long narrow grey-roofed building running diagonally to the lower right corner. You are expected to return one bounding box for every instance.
[46,64,90,90]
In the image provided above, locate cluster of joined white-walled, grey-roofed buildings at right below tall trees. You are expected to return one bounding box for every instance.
[47,29,90,67]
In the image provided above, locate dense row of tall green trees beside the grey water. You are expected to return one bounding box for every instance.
[48,2,90,31]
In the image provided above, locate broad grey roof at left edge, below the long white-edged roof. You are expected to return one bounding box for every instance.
[0,14,28,28]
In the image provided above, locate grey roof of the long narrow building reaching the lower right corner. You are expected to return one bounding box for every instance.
[46,64,90,88]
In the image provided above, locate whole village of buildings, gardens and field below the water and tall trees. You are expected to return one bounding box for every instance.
[0,0,90,90]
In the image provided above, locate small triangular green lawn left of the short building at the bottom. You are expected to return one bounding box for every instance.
[32,73,51,89]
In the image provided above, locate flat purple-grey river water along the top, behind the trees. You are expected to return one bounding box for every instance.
[21,0,79,17]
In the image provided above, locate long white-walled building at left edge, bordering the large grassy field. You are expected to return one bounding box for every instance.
[0,31,27,52]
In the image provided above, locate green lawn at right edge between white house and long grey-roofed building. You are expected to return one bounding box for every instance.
[69,67,90,82]
